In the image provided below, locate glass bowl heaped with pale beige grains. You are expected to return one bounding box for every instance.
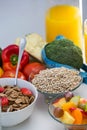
[32,67,83,103]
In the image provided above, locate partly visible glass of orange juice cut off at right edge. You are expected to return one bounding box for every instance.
[84,20,87,63]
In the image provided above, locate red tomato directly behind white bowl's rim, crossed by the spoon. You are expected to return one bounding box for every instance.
[2,70,26,80]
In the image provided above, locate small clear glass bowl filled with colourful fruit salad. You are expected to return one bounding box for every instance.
[48,92,87,130]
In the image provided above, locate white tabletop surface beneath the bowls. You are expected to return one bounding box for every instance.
[2,84,87,130]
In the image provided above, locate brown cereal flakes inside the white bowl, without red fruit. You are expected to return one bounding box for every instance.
[0,86,35,112]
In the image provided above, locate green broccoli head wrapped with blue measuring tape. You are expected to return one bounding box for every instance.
[45,39,83,69]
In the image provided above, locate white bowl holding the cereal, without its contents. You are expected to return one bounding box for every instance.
[0,78,38,127]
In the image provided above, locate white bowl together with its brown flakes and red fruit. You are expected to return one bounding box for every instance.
[0,78,38,127]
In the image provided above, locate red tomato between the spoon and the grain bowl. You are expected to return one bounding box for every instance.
[23,62,46,80]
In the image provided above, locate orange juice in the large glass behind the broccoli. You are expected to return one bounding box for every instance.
[46,5,82,49]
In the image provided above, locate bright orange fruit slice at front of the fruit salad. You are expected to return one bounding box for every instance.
[71,108,83,124]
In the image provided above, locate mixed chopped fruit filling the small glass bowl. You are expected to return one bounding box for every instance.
[52,95,87,125]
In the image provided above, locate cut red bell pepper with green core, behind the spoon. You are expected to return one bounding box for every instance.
[1,44,29,71]
